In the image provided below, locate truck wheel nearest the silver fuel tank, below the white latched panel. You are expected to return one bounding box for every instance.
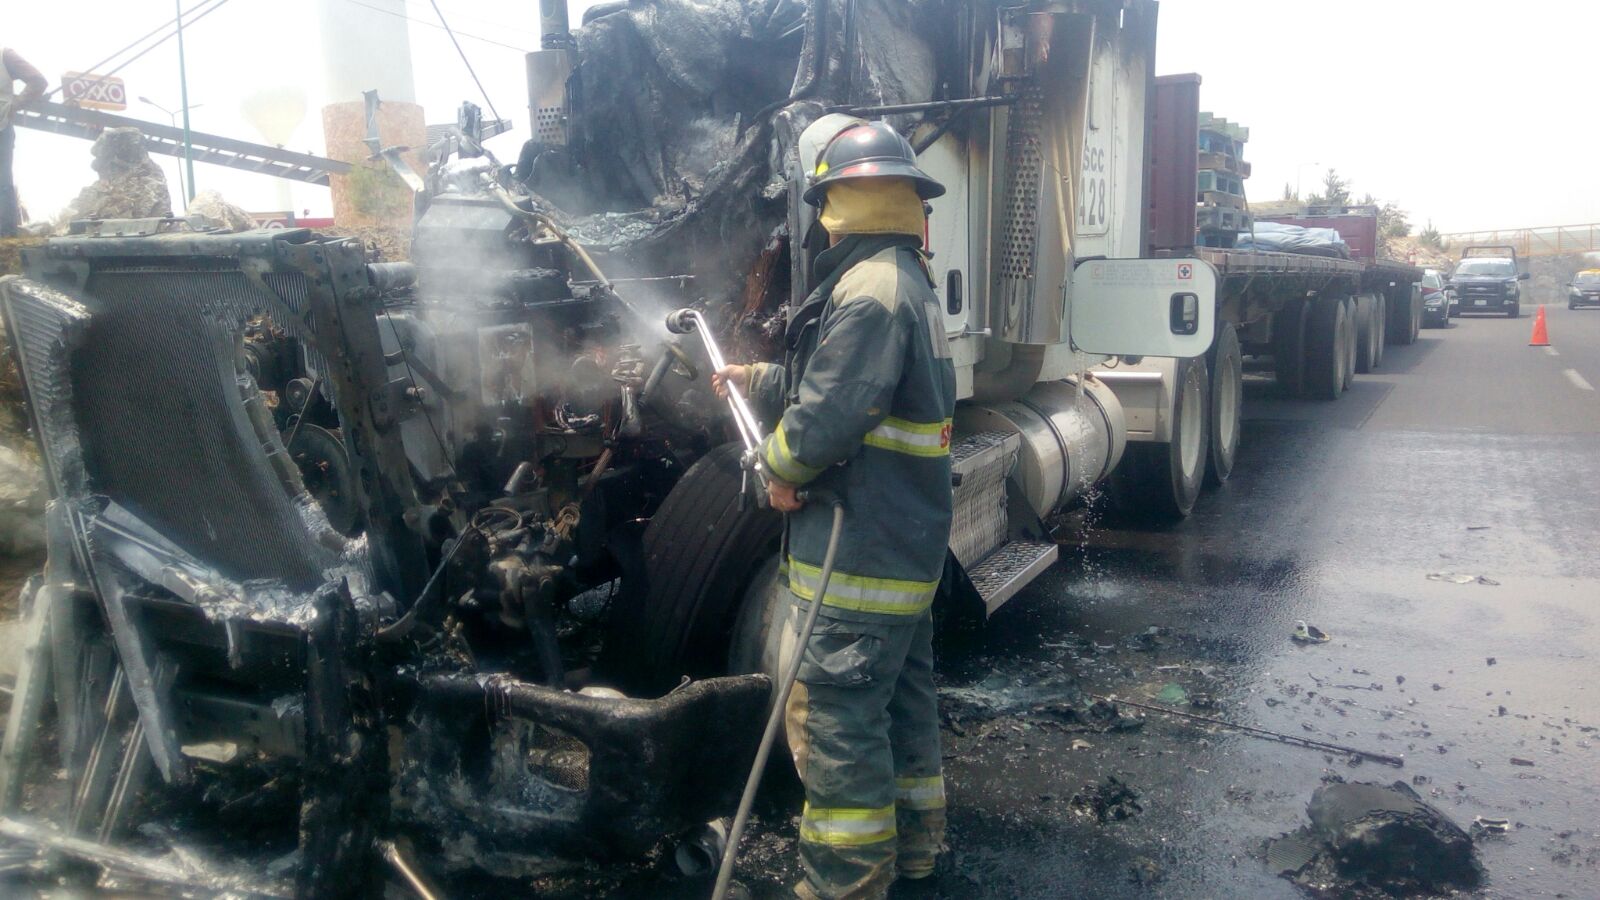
[1117,356,1211,522]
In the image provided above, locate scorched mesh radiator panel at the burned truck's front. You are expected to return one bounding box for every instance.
[72,259,334,589]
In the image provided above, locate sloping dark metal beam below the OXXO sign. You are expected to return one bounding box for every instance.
[14,101,352,186]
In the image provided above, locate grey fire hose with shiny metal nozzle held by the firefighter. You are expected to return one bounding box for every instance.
[667,309,845,900]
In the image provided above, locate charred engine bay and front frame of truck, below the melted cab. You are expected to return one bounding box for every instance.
[0,219,768,878]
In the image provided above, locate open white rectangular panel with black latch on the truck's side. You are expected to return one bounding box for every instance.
[1067,259,1218,359]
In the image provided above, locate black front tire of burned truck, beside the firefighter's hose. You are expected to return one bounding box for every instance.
[605,444,782,690]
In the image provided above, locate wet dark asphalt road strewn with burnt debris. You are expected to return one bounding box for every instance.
[592,304,1600,898]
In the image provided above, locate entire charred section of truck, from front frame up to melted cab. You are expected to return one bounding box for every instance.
[0,0,971,897]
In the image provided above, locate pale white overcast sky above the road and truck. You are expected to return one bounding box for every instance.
[0,0,1600,232]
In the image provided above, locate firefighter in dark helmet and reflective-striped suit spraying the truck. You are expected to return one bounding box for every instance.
[715,120,955,900]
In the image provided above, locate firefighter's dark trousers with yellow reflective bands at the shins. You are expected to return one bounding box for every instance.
[784,602,944,900]
